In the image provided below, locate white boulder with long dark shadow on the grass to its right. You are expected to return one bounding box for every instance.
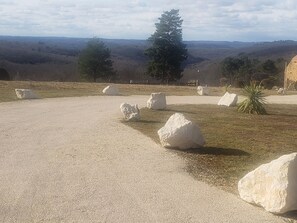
[158,113,205,149]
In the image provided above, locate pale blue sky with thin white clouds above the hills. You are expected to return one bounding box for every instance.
[0,0,297,41]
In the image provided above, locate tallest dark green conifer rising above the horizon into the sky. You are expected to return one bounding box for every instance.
[145,9,187,83]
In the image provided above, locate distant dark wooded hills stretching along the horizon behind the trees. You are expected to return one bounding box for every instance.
[0,36,297,85]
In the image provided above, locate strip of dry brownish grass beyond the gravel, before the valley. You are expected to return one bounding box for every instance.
[0,81,284,102]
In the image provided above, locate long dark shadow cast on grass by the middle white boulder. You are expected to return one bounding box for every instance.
[177,147,250,156]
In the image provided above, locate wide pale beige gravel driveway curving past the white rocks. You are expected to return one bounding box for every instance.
[0,96,292,223]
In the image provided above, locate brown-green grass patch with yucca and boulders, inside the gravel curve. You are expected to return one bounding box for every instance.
[123,105,297,193]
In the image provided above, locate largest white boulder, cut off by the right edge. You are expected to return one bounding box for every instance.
[238,153,297,214]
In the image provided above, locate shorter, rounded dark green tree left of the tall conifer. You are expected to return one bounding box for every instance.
[78,38,115,82]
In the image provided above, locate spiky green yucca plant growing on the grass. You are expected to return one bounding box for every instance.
[237,83,267,115]
